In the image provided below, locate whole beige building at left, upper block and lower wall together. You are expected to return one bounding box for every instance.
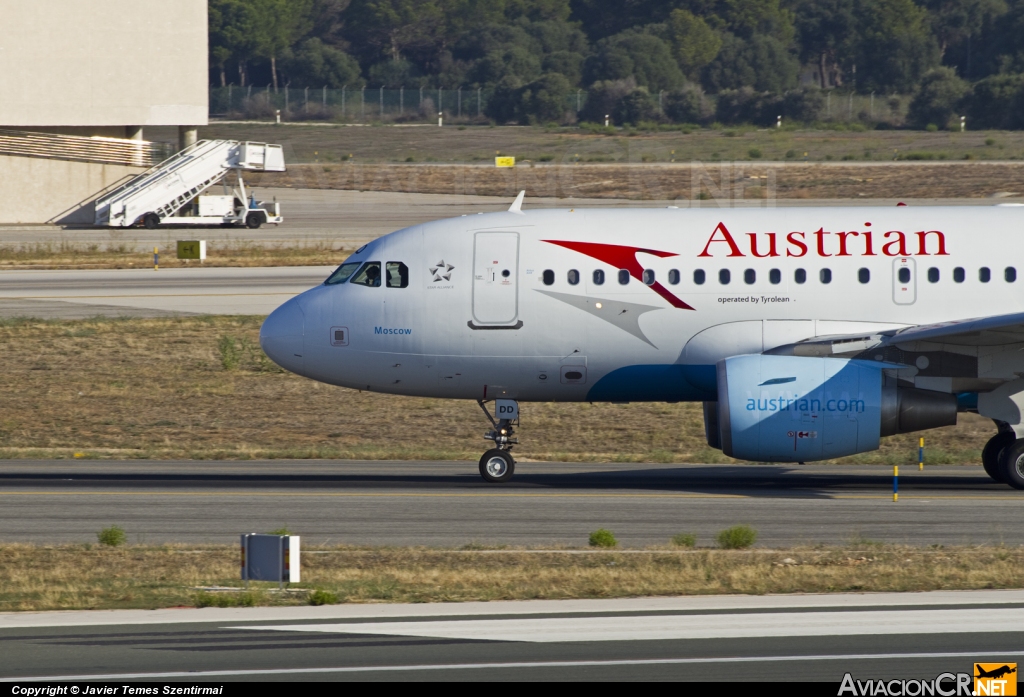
[0,0,209,224]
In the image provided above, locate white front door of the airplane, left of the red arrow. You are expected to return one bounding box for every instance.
[473,232,519,325]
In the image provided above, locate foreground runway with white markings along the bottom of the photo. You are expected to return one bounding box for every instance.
[0,591,1024,687]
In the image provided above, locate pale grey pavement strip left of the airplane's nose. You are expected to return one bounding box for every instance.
[0,266,333,319]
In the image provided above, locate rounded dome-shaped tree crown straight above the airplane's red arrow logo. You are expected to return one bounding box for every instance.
[584,30,686,92]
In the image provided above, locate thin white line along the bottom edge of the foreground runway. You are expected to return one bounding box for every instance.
[8,650,1024,683]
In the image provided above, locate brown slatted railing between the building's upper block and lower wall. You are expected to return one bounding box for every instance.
[0,129,174,167]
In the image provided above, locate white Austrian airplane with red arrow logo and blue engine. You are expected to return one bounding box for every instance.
[260,192,1024,489]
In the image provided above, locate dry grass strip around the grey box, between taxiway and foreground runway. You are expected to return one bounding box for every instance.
[6,542,1024,611]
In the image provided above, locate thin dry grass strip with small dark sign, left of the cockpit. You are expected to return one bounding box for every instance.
[0,240,351,270]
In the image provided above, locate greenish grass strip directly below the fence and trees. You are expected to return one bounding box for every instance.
[163,122,1024,166]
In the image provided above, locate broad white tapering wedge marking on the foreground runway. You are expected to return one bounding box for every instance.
[235,608,1024,643]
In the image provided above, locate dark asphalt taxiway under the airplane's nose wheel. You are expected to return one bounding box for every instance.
[0,461,1024,549]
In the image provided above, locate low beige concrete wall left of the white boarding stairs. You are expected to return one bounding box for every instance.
[0,155,145,225]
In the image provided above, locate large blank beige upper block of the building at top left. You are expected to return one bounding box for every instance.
[0,0,209,135]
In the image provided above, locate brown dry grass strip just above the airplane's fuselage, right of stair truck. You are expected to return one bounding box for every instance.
[241,162,1024,207]
